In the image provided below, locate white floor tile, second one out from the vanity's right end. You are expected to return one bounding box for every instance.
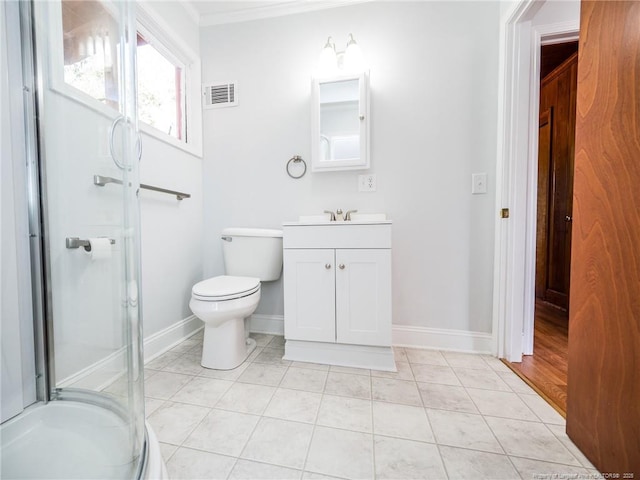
[373,402,435,442]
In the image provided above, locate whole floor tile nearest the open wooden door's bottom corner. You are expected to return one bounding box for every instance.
[485,417,579,465]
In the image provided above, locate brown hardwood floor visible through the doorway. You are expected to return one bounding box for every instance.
[505,300,569,417]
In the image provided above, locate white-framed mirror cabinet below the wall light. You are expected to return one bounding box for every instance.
[311,74,369,172]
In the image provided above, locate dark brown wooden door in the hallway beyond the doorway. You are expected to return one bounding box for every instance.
[536,53,578,310]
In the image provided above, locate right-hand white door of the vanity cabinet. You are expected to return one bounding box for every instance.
[336,249,391,346]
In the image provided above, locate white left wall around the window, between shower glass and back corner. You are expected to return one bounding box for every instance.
[140,2,203,338]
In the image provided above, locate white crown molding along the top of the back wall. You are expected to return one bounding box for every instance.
[200,0,372,27]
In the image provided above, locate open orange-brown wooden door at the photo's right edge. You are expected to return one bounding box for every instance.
[567,1,640,472]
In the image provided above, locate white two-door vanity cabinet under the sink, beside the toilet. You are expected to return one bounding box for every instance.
[283,221,395,370]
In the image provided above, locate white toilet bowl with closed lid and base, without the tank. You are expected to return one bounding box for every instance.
[189,275,260,370]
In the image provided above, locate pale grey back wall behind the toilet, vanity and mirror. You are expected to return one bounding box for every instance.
[201,2,500,342]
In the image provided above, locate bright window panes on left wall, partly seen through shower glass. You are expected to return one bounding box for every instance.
[61,0,186,142]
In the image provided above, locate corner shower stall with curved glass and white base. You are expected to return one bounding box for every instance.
[0,0,164,479]
